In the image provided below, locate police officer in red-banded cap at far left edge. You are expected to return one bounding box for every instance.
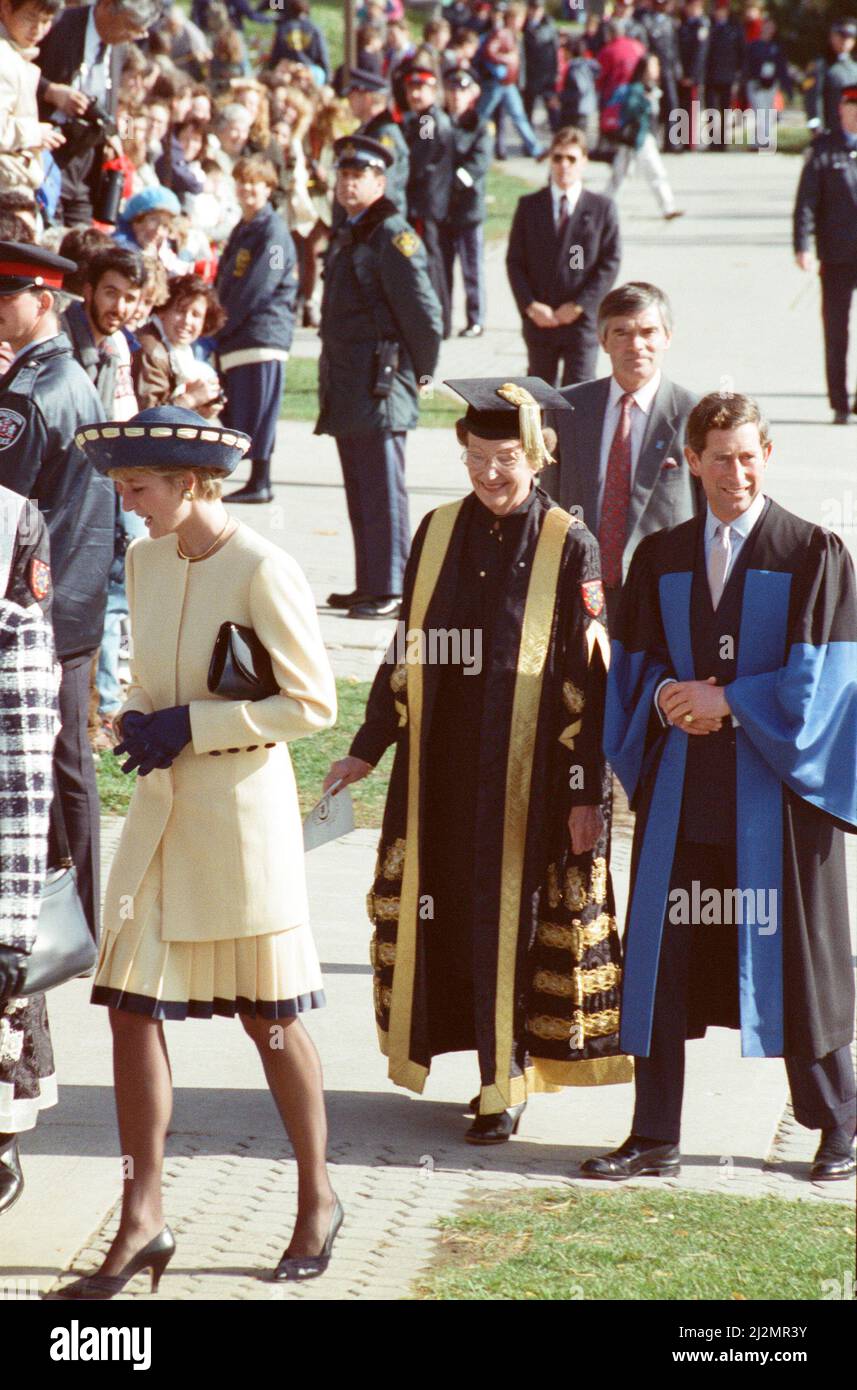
[0,242,114,935]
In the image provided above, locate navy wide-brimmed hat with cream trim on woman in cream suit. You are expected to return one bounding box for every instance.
[75,406,250,475]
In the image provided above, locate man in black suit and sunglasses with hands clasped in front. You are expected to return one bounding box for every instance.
[506,125,622,386]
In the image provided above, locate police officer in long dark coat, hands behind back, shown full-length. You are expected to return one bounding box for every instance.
[315,135,442,617]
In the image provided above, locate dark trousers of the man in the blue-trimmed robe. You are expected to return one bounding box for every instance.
[632,841,854,1144]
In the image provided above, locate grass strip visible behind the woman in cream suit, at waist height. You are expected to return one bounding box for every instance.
[96,680,393,827]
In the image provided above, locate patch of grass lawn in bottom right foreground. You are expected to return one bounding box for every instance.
[414,1187,854,1301]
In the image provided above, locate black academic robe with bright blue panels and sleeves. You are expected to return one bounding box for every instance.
[604,502,857,1059]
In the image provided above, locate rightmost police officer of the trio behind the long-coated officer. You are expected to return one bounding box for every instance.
[440,68,494,338]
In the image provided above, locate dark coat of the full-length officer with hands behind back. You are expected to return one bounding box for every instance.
[315,197,442,435]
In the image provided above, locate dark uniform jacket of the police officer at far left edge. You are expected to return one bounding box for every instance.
[0,334,114,660]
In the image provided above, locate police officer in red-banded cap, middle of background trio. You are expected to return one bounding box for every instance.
[401,67,456,338]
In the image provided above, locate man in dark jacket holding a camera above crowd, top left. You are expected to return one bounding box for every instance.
[38,0,163,227]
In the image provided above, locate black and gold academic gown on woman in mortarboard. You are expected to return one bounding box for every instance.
[351,489,631,1113]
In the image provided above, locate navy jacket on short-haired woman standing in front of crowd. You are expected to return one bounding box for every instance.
[215,203,297,356]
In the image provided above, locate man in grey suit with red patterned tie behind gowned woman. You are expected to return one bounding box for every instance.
[543,282,700,621]
